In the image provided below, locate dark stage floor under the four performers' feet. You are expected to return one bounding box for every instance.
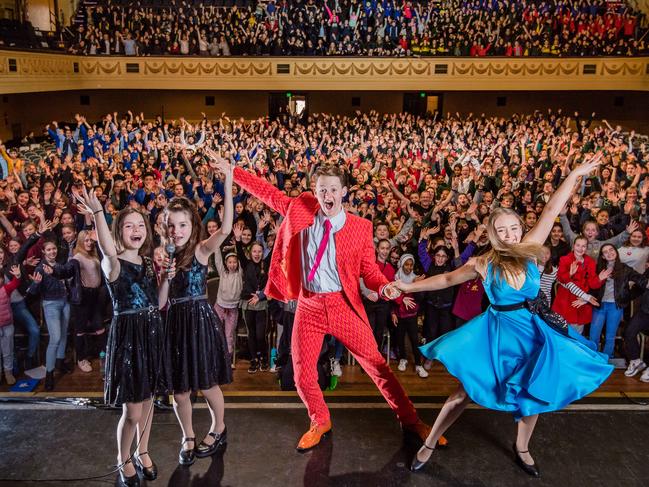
[0,402,649,487]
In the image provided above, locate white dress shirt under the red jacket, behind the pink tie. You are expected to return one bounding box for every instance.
[300,210,347,293]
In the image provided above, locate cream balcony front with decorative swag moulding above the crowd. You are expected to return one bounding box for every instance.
[0,50,649,93]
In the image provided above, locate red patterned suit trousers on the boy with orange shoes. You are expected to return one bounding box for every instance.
[291,290,418,425]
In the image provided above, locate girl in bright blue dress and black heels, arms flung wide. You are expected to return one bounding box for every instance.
[395,153,613,477]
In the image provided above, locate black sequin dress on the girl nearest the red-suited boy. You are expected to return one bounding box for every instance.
[167,257,232,393]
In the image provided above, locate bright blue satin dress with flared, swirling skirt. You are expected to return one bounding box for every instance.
[420,262,613,421]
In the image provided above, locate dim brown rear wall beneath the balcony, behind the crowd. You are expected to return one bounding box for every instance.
[0,90,649,140]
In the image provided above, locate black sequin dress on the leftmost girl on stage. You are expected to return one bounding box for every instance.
[104,257,170,405]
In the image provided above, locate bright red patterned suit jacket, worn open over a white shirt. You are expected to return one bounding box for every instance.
[234,167,389,322]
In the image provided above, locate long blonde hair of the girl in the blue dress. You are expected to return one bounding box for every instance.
[481,208,543,283]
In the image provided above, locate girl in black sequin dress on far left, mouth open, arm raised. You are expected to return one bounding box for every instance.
[76,188,174,486]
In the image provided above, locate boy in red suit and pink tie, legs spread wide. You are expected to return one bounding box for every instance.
[234,166,438,451]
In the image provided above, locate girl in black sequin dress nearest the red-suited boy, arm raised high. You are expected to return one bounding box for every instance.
[166,150,233,465]
